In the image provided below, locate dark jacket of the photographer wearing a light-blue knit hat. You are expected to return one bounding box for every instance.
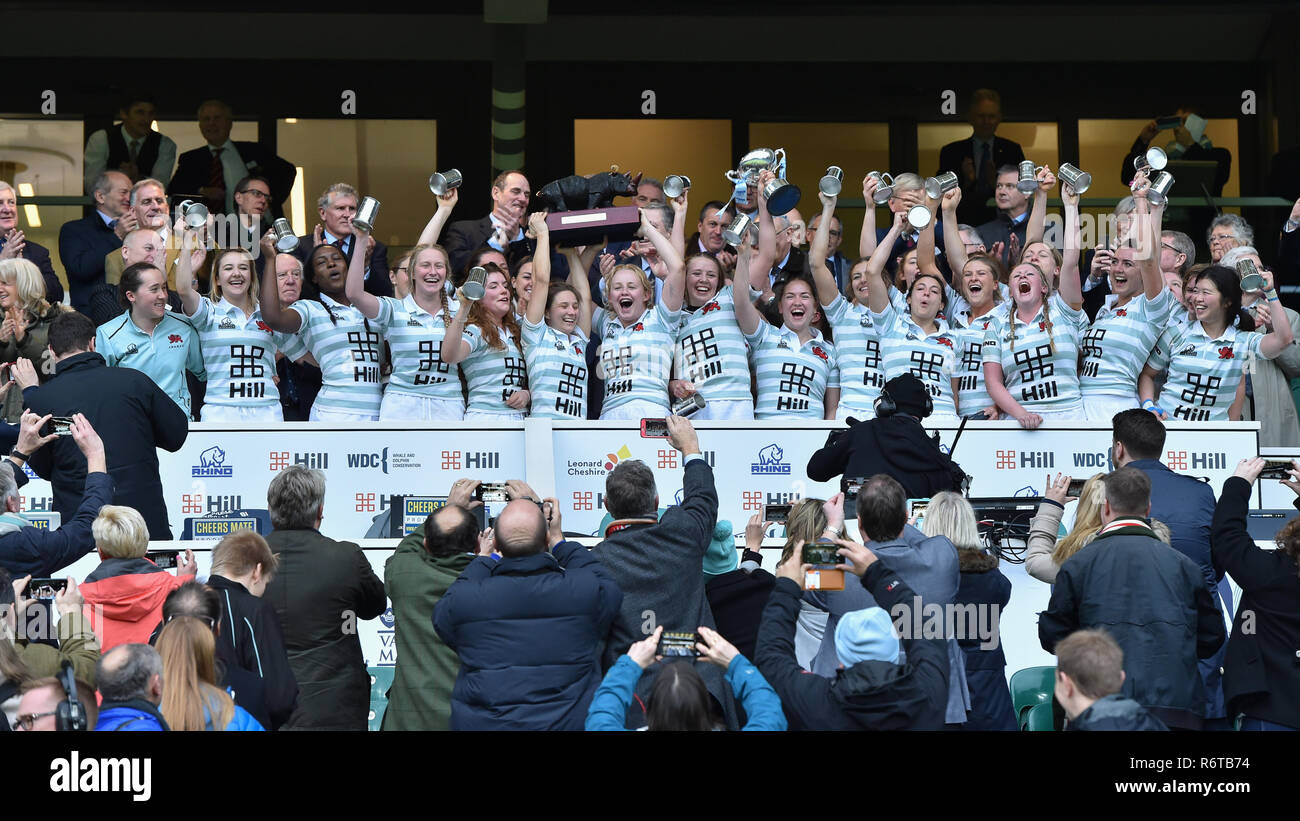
[754,560,948,730]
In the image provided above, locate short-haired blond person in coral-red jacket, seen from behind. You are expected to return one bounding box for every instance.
[81,504,198,652]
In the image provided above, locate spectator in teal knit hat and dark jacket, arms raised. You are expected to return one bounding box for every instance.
[705,513,776,659]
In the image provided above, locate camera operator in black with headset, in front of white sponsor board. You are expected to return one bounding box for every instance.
[807,373,966,499]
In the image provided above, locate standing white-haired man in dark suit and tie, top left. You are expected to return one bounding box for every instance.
[172,100,298,217]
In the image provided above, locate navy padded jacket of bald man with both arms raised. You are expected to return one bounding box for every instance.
[433,542,621,730]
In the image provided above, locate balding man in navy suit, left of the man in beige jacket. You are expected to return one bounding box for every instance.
[59,171,139,313]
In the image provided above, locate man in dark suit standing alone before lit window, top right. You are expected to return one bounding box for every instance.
[939,88,1024,225]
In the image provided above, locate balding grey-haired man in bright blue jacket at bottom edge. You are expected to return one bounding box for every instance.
[95,644,172,733]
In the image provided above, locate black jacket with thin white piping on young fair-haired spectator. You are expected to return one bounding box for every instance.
[208,575,298,730]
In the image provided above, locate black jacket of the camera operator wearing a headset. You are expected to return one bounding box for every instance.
[807,413,963,499]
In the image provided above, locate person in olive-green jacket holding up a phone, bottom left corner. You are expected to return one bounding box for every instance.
[0,568,99,729]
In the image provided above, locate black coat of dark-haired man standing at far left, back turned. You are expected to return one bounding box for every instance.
[25,353,190,540]
